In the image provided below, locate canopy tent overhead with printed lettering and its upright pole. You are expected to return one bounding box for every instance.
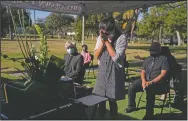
[0,0,175,43]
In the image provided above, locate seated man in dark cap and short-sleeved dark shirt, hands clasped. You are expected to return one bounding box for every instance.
[125,42,169,119]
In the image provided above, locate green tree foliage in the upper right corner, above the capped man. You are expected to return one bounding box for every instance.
[136,1,187,40]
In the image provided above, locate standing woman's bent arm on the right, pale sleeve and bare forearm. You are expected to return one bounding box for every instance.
[105,35,128,62]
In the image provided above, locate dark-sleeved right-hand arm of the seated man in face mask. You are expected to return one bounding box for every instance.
[66,56,84,78]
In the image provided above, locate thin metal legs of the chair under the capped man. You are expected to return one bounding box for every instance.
[137,83,171,114]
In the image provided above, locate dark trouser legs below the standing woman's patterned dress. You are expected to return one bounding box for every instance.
[99,100,118,120]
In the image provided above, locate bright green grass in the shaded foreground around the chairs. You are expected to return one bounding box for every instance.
[85,77,185,120]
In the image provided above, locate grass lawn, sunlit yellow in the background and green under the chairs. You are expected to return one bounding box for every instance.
[1,38,187,120]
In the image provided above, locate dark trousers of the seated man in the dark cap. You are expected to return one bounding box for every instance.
[128,80,166,115]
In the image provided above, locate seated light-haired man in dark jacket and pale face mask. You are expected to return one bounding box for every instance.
[64,42,84,84]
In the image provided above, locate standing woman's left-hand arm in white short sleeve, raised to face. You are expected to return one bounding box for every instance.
[94,36,104,59]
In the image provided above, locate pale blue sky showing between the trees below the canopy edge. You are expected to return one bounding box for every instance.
[30,10,142,22]
